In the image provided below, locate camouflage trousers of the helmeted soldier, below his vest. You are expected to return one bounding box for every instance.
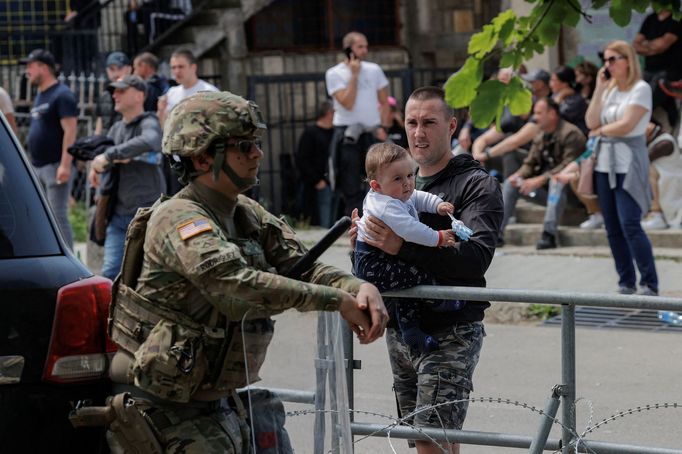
[107,403,246,454]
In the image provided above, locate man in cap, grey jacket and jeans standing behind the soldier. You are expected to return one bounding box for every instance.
[90,75,166,280]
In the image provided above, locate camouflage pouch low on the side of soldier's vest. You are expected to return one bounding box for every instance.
[133,320,207,402]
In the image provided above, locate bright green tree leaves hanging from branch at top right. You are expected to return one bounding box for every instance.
[445,0,682,127]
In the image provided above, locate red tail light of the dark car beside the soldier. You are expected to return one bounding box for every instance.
[43,276,116,383]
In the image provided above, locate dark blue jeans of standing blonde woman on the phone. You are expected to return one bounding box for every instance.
[594,172,658,292]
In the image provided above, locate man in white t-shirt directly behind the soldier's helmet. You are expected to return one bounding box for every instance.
[157,49,218,127]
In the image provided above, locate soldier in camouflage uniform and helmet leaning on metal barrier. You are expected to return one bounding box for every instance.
[103,92,388,453]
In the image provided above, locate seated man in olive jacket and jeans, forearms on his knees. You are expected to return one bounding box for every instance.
[498,98,585,249]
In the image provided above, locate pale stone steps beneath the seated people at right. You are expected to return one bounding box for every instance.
[504,199,682,254]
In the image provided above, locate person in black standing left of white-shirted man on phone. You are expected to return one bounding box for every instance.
[296,101,336,227]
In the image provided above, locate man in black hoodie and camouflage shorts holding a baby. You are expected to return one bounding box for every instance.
[354,87,503,454]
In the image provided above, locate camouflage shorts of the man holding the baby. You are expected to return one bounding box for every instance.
[386,322,485,429]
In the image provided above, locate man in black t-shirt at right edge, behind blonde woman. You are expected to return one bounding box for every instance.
[632,10,682,128]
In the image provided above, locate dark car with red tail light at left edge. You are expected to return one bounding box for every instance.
[0,114,115,454]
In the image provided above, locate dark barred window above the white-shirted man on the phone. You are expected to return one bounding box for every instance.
[246,0,399,51]
